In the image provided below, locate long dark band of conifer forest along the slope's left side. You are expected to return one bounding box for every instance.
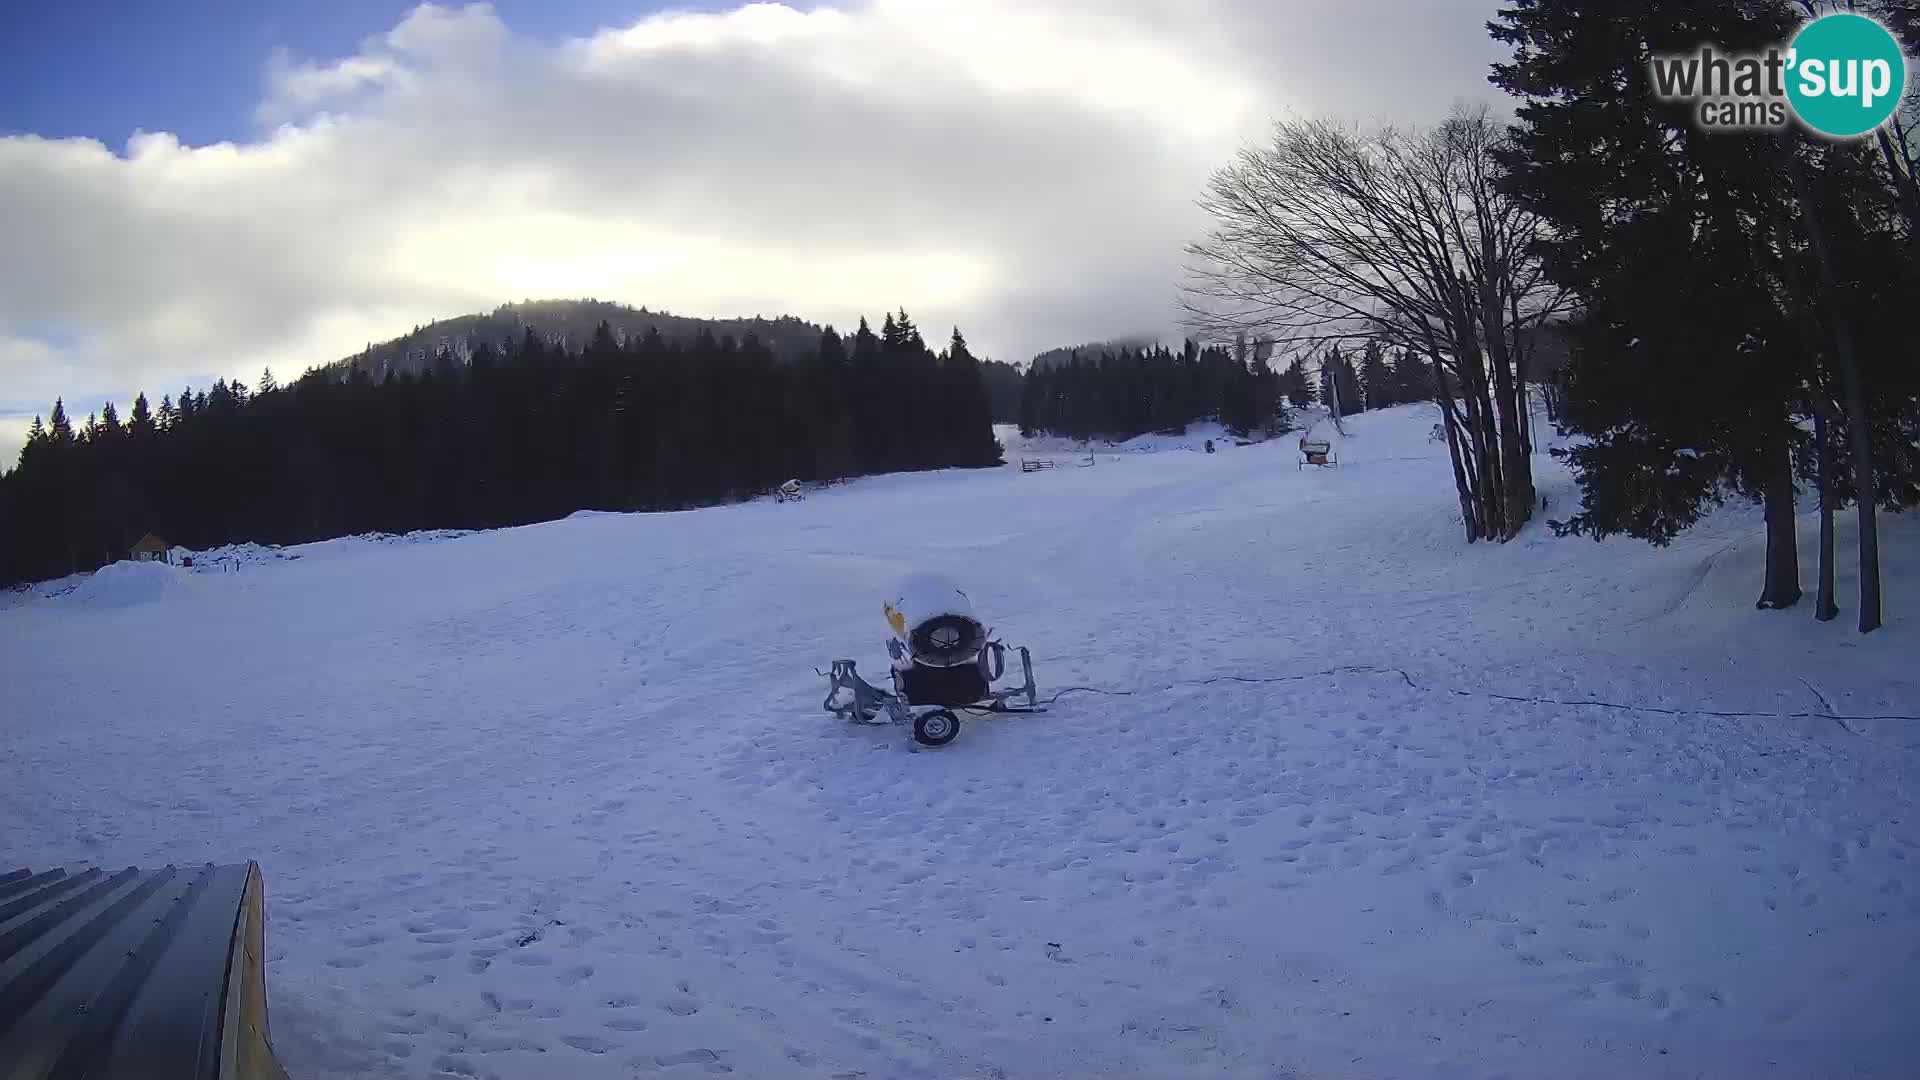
[0,311,990,582]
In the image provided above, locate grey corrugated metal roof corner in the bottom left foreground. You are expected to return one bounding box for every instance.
[0,863,284,1080]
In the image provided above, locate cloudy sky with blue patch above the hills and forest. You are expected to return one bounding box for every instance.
[0,0,1500,463]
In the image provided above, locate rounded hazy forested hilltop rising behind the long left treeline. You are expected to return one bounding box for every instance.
[328,300,822,380]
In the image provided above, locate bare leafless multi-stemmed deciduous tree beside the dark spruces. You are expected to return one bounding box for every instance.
[1185,108,1565,542]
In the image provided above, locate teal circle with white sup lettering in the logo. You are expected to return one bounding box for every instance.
[1788,12,1907,138]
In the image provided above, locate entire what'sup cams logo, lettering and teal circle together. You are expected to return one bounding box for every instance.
[1651,12,1907,138]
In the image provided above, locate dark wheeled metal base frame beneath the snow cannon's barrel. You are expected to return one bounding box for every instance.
[820,640,1046,746]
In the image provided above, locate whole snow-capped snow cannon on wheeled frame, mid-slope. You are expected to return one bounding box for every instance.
[822,575,1043,746]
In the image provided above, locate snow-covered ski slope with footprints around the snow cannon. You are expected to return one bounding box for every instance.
[0,407,1920,1080]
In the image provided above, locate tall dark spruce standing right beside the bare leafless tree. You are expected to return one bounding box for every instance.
[1490,0,1807,607]
